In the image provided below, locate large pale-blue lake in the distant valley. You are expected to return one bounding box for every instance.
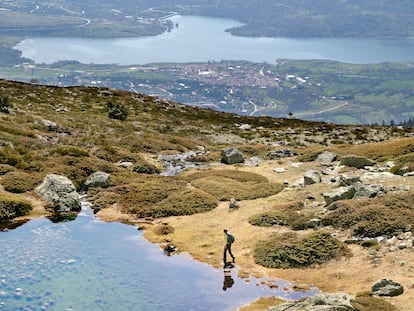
[16,16,414,65]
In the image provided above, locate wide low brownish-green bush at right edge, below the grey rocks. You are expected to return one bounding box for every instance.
[323,192,414,238]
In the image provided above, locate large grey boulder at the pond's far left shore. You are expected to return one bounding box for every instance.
[35,174,81,212]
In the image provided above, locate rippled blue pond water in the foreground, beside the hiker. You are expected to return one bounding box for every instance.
[0,202,317,311]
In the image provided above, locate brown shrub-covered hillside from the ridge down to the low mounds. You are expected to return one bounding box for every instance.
[0,80,412,222]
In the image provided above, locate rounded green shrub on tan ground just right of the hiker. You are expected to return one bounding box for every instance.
[254,231,350,268]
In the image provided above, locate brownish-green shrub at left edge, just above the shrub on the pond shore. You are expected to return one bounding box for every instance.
[1,171,41,193]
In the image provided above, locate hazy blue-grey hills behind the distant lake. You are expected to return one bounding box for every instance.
[0,0,414,37]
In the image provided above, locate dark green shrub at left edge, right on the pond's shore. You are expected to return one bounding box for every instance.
[0,193,32,222]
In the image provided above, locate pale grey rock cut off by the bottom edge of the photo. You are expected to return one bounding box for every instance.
[267,294,355,311]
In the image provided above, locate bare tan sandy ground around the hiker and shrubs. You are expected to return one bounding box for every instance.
[98,161,414,311]
